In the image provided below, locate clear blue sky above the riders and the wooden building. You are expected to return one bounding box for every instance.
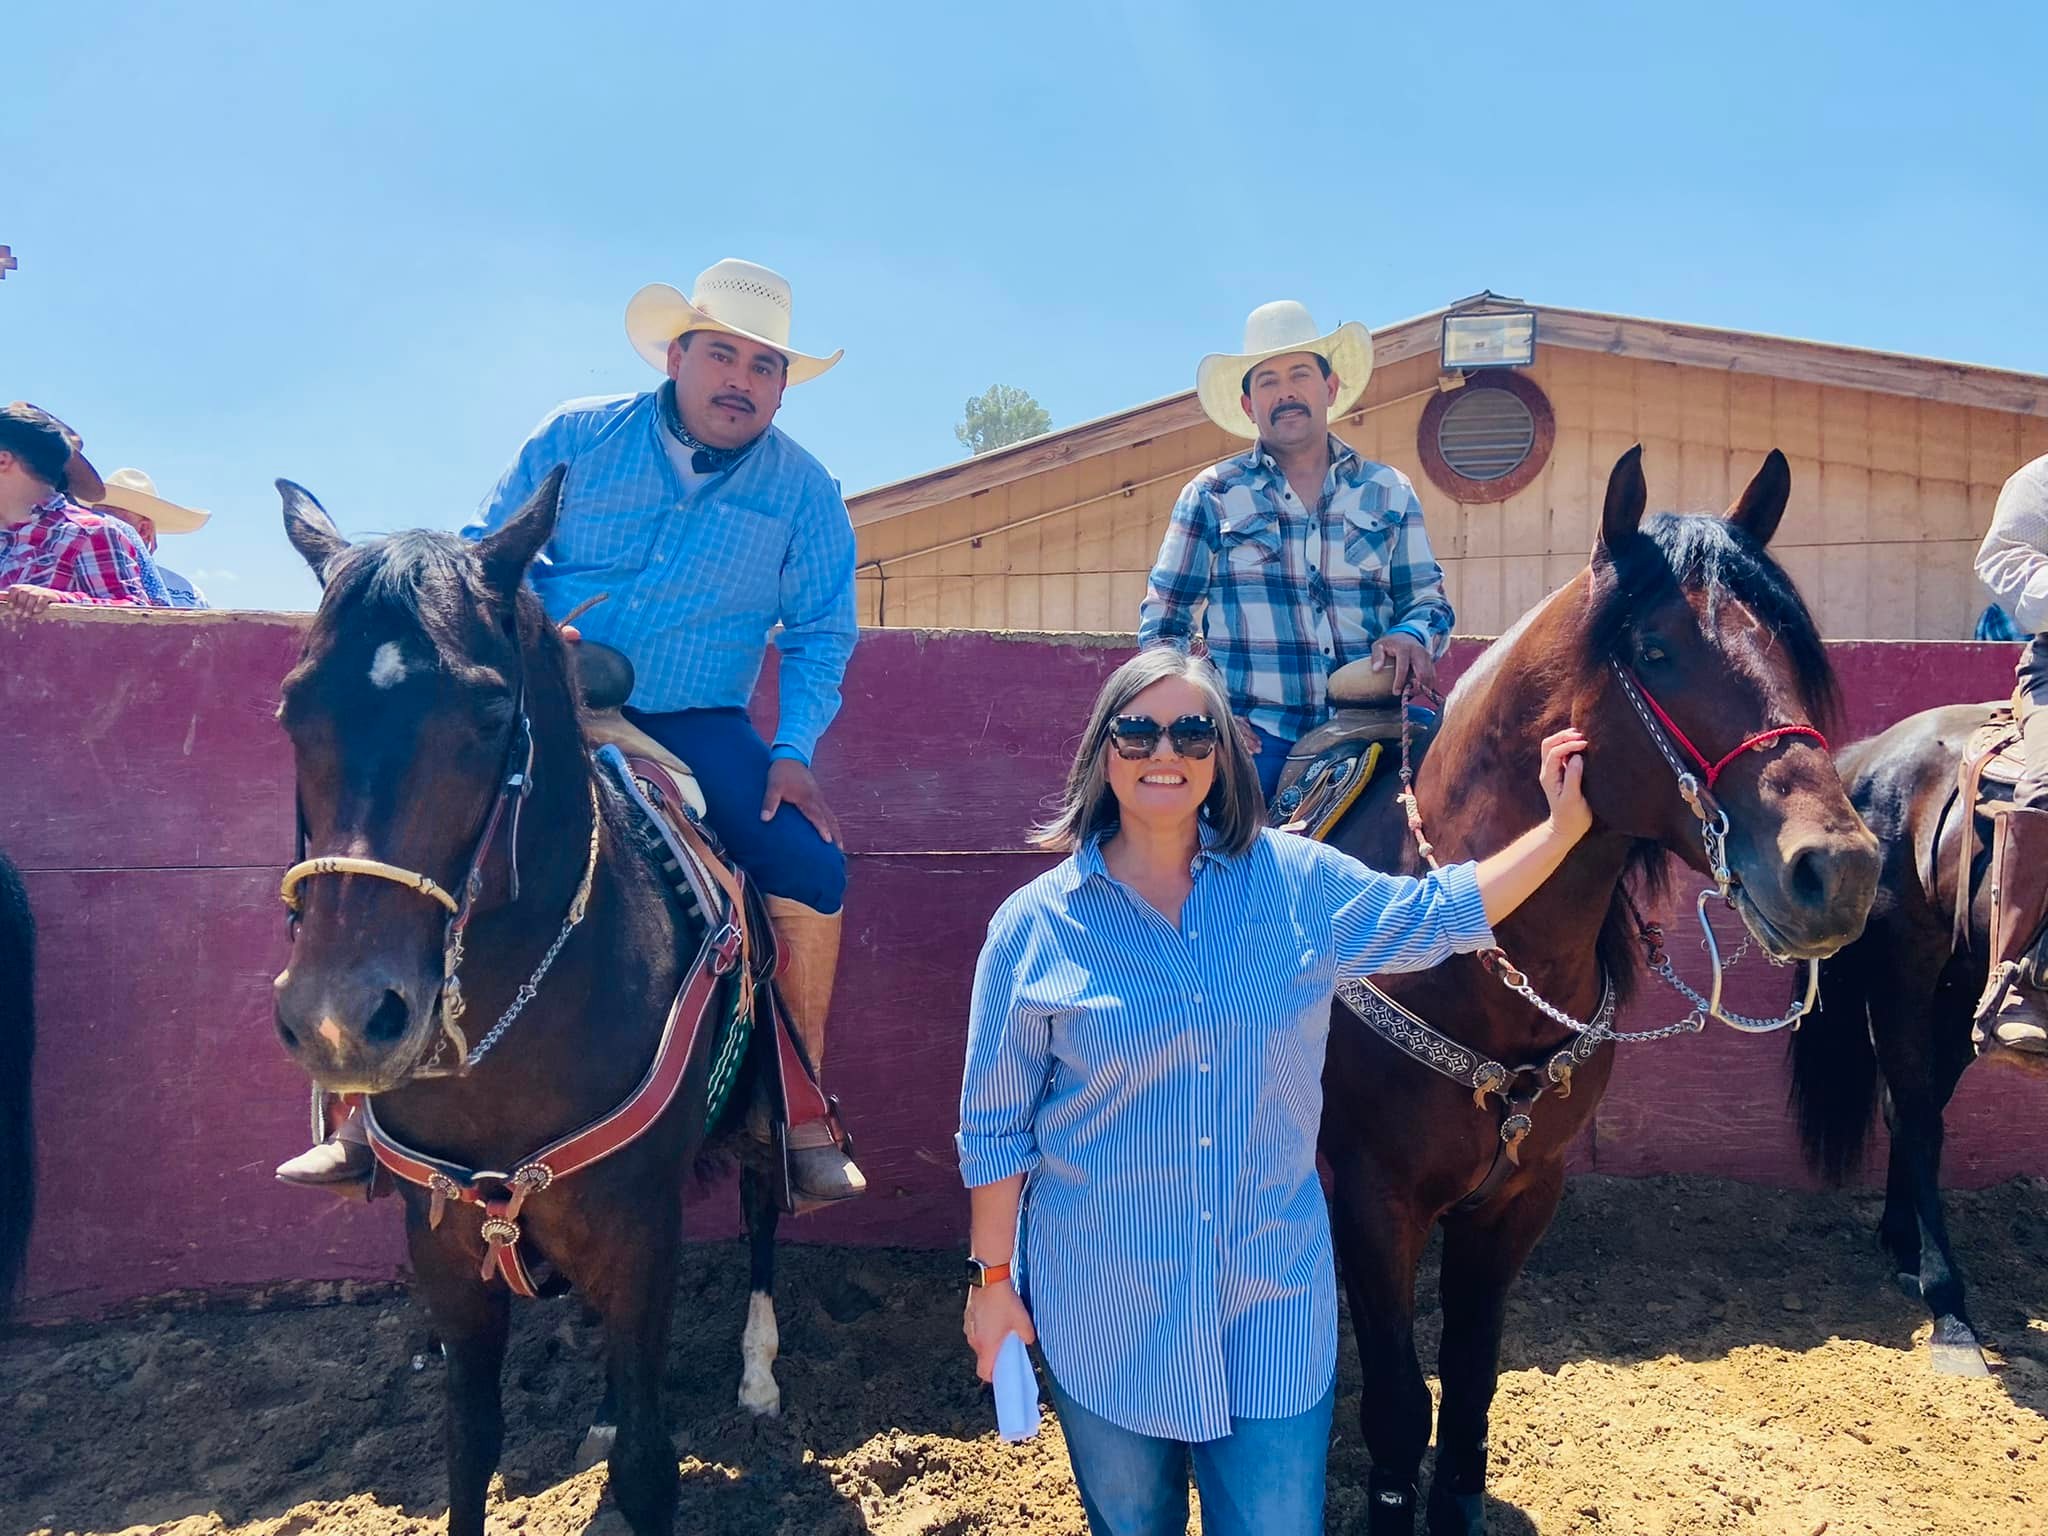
[0,0,2048,606]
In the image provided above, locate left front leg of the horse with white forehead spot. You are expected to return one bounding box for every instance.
[408,1221,512,1536]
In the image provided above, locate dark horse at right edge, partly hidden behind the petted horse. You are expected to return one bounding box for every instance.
[1792,705,2042,1376]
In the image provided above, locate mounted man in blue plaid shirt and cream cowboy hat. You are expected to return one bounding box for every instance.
[1139,299,1452,799]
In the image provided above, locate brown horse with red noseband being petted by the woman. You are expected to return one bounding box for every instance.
[1323,449,1878,1536]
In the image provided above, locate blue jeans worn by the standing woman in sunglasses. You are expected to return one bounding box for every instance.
[1044,1370,1337,1536]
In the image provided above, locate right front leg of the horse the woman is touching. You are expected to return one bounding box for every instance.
[1427,1161,1565,1536]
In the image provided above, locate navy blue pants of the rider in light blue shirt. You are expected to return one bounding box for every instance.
[627,709,846,913]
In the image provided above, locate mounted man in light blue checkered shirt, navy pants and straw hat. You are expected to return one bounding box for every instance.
[279,260,866,1202]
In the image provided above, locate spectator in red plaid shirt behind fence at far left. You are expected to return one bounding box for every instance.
[0,401,170,616]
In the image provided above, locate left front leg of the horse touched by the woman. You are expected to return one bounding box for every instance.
[1331,1169,1430,1536]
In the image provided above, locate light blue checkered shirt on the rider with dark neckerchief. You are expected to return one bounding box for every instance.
[463,389,858,762]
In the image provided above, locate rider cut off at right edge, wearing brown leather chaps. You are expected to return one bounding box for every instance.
[1976,455,2048,1053]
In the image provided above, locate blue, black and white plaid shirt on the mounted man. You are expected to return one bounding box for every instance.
[1139,436,1452,741]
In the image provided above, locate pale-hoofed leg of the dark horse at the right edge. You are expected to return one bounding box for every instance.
[1874,1014,1991,1376]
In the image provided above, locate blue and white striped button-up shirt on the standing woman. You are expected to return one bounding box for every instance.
[958,831,1493,1442]
